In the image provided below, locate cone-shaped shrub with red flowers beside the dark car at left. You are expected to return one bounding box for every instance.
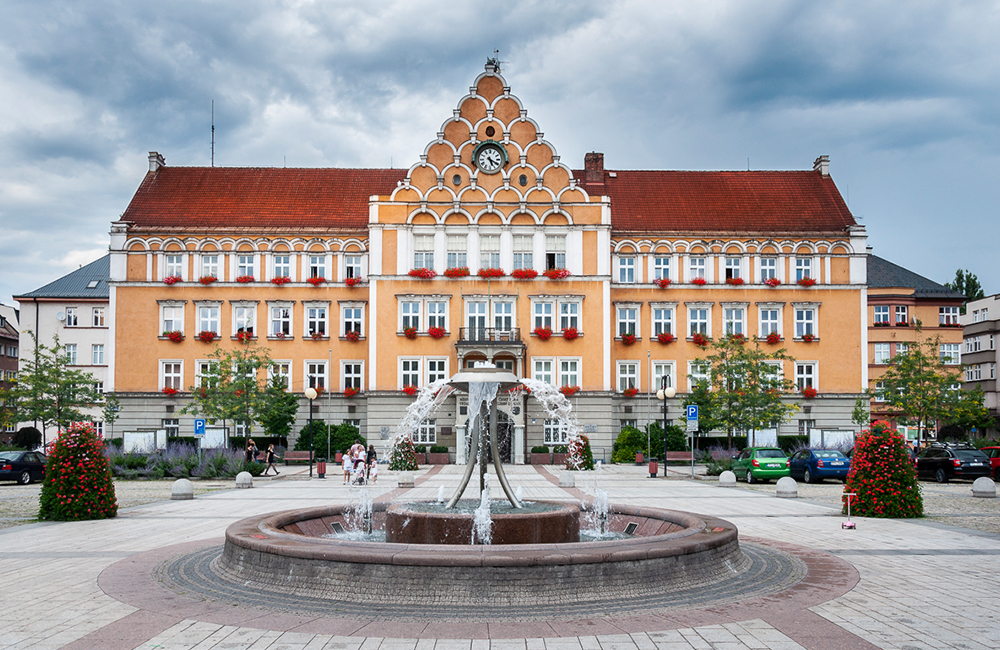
[38,424,118,521]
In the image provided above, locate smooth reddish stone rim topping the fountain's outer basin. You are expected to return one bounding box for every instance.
[226,501,738,566]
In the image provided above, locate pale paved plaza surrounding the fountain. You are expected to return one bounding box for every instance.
[0,466,1000,650]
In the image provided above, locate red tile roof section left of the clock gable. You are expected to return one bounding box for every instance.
[122,167,406,229]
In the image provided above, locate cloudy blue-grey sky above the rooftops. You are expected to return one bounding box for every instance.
[0,0,1000,304]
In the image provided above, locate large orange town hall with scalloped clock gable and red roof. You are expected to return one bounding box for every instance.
[108,63,867,462]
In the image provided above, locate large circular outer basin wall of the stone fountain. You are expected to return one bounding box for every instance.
[221,503,750,607]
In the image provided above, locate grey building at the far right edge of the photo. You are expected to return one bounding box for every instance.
[962,294,1000,437]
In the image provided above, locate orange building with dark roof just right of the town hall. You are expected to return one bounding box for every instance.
[868,254,965,440]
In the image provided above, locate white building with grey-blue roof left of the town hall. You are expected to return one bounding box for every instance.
[14,255,111,432]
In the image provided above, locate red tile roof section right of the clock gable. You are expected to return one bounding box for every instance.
[573,170,856,233]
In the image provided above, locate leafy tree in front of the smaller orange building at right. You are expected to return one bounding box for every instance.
[878,321,990,439]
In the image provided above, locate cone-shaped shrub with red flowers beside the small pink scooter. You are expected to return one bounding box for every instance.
[842,420,924,518]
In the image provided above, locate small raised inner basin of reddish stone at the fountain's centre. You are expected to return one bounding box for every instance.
[385,501,580,545]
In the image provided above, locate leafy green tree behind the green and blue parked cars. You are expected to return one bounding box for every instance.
[699,336,798,447]
